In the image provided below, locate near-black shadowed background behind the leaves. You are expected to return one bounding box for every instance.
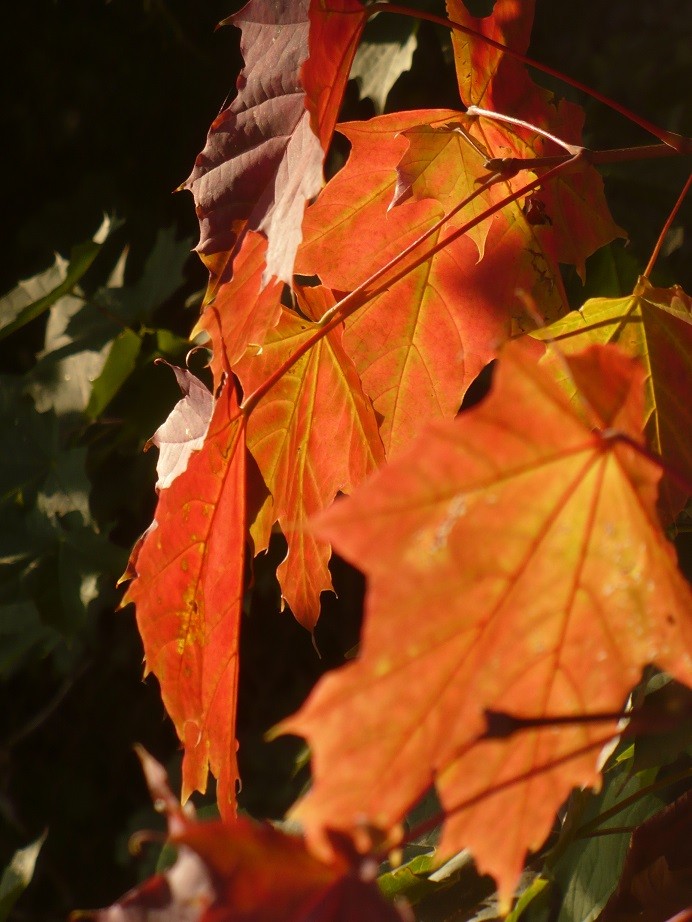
[0,0,692,920]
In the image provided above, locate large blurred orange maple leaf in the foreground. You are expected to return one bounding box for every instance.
[280,343,692,898]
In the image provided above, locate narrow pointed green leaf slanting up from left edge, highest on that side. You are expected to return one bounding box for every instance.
[0,218,111,340]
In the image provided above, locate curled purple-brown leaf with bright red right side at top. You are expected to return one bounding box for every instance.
[181,0,364,295]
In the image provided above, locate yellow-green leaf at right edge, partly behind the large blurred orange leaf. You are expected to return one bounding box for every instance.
[532,278,692,523]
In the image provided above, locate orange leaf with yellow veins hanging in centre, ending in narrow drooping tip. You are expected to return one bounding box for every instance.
[236,288,384,630]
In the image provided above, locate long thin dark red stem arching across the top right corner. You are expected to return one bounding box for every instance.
[367,0,692,154]
